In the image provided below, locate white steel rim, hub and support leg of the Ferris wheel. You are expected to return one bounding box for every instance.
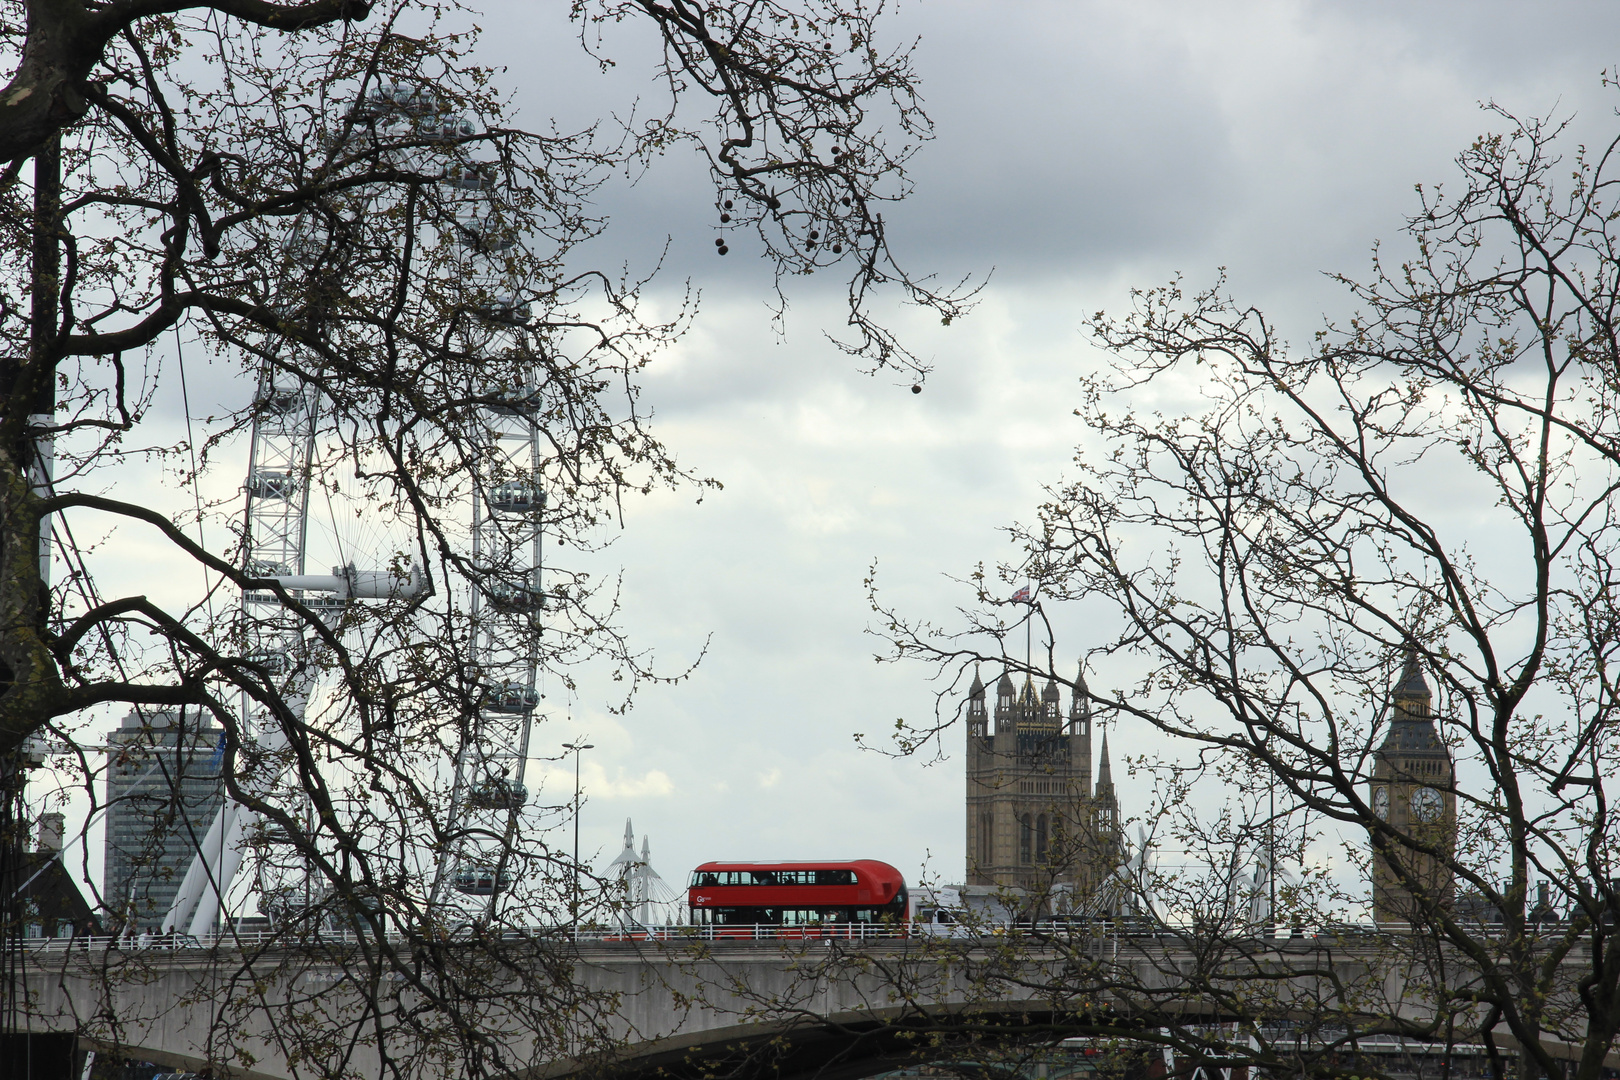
[162,84,546,936]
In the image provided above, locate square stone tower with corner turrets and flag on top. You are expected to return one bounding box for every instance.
[967,674,1121,908]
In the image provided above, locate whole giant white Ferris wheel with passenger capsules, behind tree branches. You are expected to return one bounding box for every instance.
[164,84,549,934]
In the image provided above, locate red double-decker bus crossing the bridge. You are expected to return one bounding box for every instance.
[687,858,909,936]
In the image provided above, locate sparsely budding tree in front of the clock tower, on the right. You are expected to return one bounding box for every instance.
[873,86,1620,1080]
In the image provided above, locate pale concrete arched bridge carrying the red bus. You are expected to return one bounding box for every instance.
[12,933,1509,1080]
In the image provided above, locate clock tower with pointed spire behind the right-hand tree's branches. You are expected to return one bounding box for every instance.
[1371,653,1456,923]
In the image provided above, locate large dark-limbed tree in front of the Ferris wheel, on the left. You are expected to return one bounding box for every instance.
[0,0,969,1075]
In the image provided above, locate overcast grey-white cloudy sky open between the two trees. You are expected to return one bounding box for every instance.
[50,0,1620,919]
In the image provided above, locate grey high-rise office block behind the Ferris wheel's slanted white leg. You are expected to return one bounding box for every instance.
[102,709,225,929]
